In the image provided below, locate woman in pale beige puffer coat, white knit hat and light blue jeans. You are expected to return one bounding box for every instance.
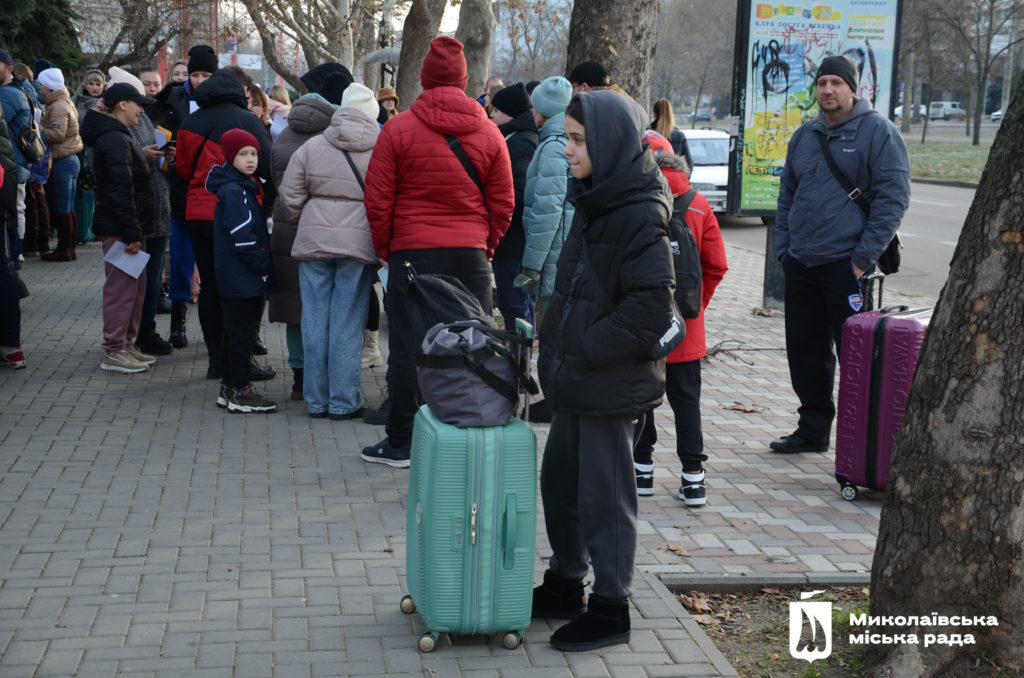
[278,84,380,420]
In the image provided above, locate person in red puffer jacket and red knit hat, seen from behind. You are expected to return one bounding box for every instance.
[362,37,515,468]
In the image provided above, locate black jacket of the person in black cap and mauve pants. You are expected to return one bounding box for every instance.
[81,109,154,244]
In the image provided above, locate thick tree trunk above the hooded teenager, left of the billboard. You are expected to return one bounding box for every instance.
[565,0,660,111]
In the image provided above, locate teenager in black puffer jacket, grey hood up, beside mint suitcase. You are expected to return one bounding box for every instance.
[534,91,675,651]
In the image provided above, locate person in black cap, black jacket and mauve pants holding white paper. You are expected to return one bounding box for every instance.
[82,83,157,374]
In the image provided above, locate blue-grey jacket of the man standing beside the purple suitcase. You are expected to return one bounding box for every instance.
[775,99,910,270]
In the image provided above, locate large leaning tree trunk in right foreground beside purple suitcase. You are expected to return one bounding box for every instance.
[871,67,1024,678]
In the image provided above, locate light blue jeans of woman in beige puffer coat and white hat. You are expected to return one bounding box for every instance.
[299,258,374,415]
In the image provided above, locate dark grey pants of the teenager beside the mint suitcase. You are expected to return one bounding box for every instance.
[541,412,644,600]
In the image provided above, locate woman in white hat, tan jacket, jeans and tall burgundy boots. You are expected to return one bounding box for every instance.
[36,69,83,261]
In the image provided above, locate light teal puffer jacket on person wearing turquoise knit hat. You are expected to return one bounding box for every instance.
[522,113,574,297]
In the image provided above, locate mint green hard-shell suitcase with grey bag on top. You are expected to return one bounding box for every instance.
[401,406,537,652]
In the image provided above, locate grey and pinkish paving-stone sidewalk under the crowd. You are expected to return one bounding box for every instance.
[0,245,929,678]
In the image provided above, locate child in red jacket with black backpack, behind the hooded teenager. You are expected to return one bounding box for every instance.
[633,130,728,507]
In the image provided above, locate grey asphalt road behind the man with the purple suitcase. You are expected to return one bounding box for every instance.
[720,181,975,299]
